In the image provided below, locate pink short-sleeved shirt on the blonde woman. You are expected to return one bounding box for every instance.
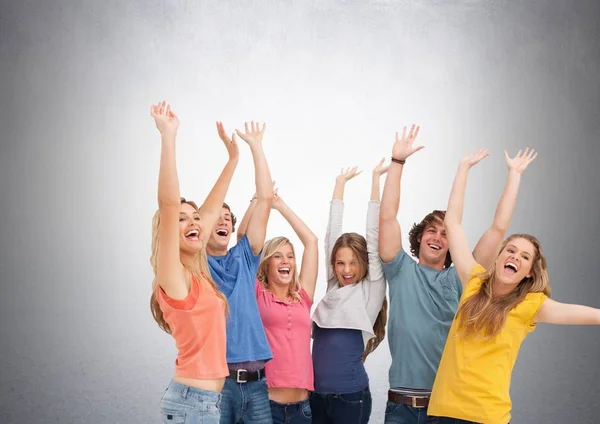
[256,280,314,390]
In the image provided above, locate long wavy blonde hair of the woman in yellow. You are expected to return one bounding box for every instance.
[456,234,550,340]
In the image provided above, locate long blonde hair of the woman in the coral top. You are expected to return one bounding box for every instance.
[150,197,229,334]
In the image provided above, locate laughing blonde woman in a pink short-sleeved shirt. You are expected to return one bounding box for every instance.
[256,194,319,424]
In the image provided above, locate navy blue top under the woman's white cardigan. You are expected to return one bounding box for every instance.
[312,324,369,395]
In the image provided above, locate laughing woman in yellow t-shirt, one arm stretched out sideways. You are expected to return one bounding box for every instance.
[428,149,600,424]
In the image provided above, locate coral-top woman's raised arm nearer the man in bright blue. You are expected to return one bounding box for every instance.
[200,122,240,246]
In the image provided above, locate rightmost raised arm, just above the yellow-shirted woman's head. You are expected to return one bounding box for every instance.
[473,148,537,268]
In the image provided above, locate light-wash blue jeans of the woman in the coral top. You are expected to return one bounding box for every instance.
[160,381,221,424]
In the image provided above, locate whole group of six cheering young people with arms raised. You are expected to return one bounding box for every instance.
[151,101,600,424]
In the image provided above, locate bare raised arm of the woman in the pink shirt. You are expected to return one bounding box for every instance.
[273,192,319,301]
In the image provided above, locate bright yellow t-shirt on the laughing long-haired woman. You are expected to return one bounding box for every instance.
[427,264,547,424]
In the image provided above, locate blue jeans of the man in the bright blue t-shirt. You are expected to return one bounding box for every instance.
[221,377,273,424]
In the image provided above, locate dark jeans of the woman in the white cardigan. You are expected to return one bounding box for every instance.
[310,386,372,424]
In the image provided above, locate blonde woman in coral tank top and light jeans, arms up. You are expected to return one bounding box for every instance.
[150,101,238,424]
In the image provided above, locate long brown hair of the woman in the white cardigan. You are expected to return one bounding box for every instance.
[329,233,388,362]
